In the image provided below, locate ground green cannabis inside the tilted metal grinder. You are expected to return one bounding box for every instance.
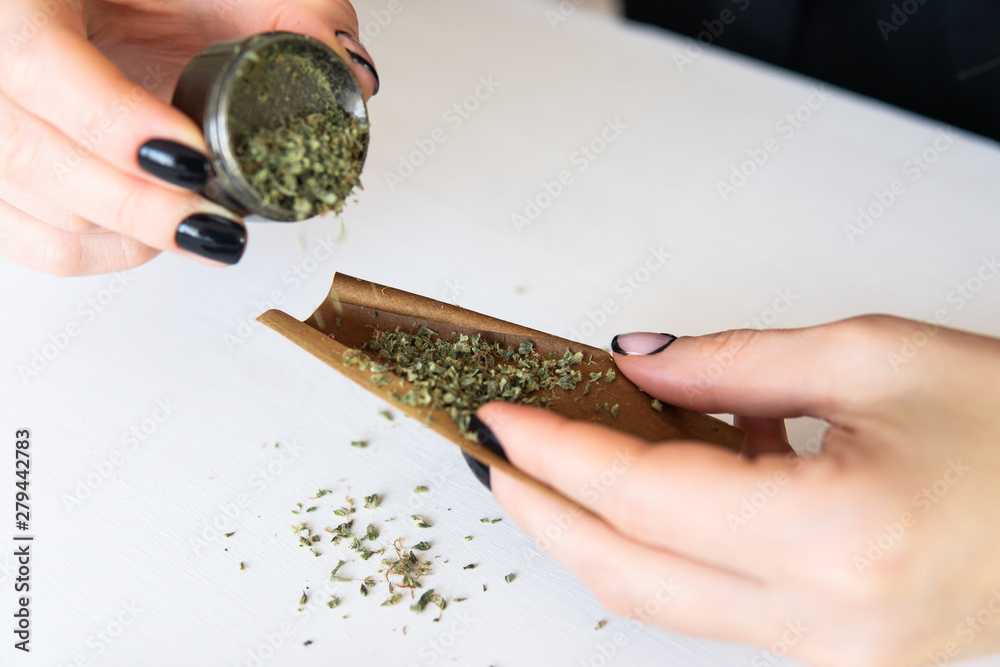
[230,52,368,220]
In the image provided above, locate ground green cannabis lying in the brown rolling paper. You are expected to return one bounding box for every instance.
[344,327,583,438]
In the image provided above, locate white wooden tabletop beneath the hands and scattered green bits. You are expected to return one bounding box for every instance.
[0,0,1000,667]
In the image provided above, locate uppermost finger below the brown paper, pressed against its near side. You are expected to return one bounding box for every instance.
[478,403,799,577]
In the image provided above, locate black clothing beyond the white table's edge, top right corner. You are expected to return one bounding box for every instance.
[625,0,1000,140]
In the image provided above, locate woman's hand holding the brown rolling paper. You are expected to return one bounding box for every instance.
[479,316,1000,667]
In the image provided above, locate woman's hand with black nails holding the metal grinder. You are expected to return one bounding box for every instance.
[0,0,378,275]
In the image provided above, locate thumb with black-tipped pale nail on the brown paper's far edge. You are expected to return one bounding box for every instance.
[612,316,915,421]
